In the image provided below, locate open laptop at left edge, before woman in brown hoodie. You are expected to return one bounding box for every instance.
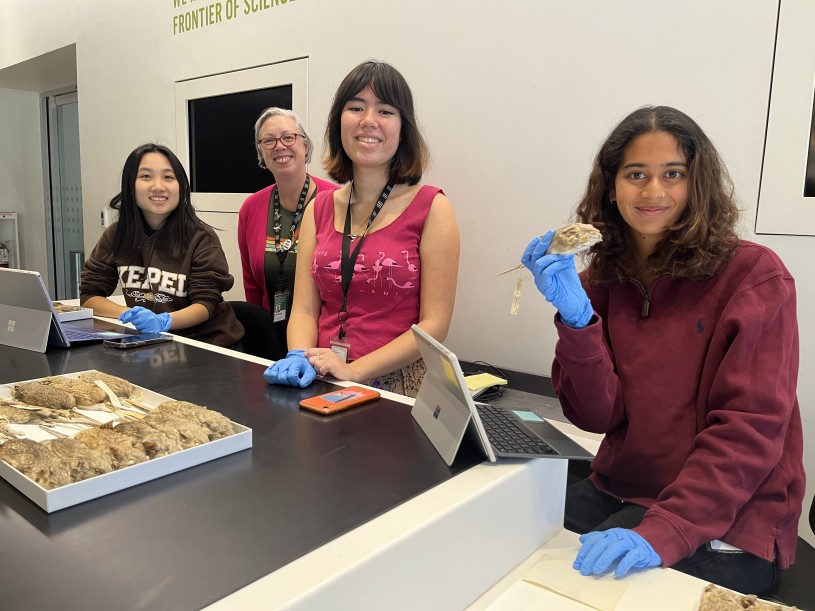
[0,268,129,352]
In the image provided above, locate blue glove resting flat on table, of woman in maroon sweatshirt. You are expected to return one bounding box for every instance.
[572,528,662,577]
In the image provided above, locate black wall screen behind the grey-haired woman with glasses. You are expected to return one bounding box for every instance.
[187,85,293,193]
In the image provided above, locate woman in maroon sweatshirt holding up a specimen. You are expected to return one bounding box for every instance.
[522,106,804,594]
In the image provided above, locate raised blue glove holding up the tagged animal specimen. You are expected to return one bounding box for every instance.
[521,231,594,329]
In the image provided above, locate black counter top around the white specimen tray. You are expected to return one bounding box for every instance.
[0,342,483,611]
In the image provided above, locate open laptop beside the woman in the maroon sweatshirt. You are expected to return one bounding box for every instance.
[411,325,594,465]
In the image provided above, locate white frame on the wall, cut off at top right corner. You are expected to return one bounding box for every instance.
[756,0,815,235]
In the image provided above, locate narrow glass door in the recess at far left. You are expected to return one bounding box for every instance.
[42,90,85,299]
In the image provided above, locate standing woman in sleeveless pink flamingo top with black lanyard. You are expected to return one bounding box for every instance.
[264,61,459,396]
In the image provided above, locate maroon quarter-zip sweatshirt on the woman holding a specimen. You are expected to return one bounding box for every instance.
[552,242,805,568]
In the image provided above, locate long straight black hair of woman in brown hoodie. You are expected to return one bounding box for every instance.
[110,143,209,257]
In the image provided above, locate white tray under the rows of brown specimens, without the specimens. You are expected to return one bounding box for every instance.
[0,371,252,513]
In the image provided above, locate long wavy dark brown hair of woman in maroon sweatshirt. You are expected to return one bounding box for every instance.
[576,106,739,285]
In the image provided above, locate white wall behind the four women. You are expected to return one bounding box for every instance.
[0,0,815,544]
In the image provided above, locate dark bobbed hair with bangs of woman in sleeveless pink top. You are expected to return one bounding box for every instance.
[323,60,430,185]
